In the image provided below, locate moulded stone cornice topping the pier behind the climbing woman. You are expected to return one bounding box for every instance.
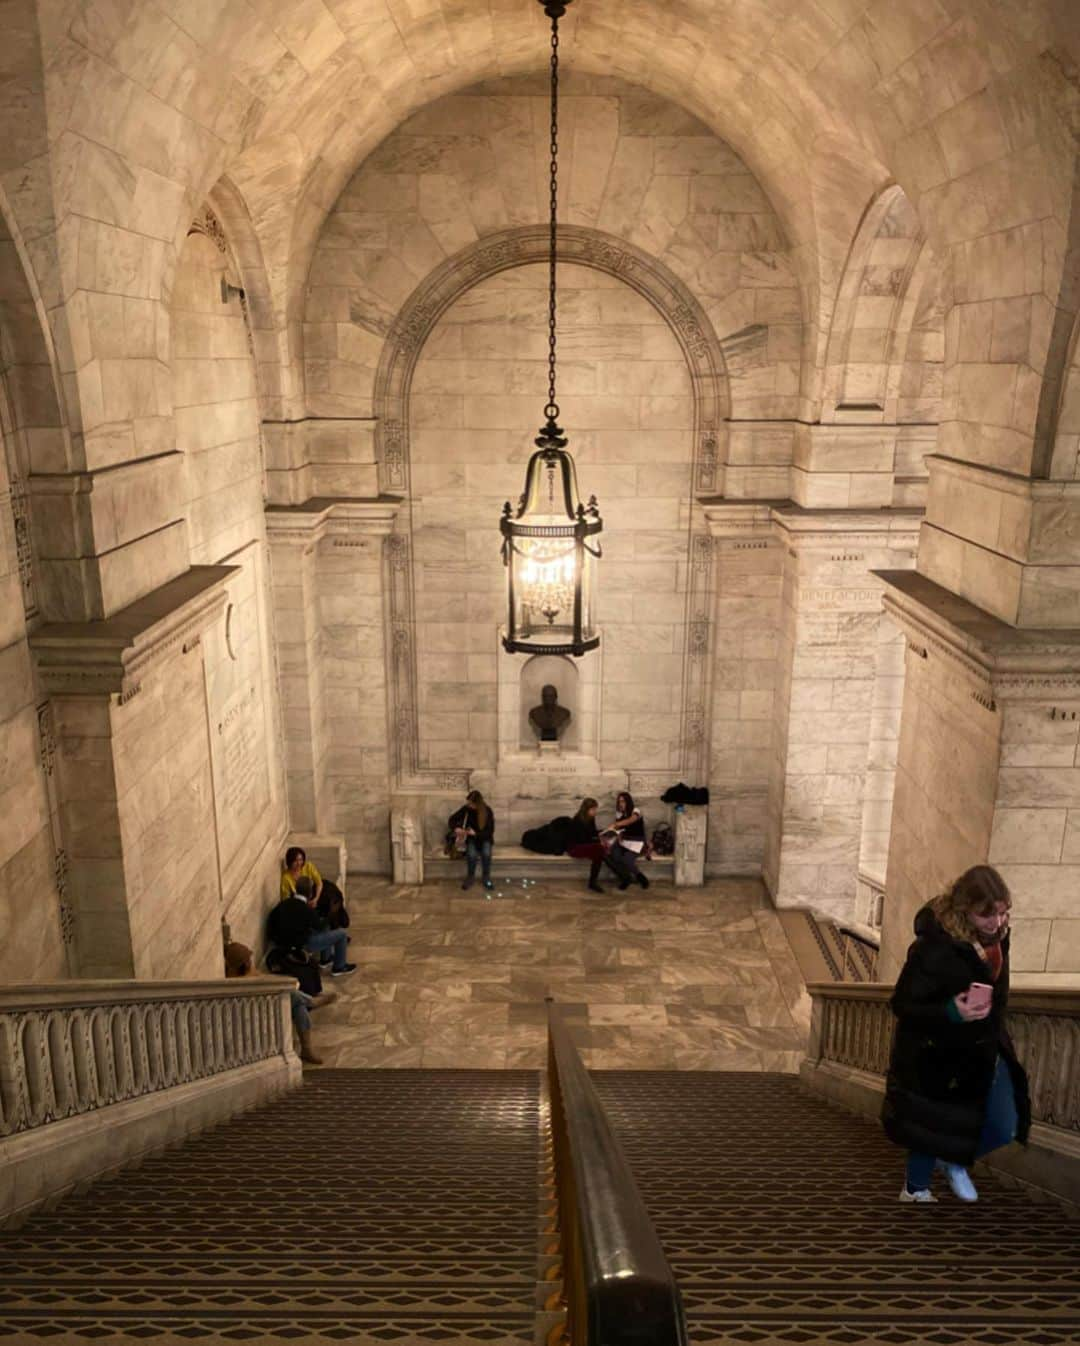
[874,571,1080,708]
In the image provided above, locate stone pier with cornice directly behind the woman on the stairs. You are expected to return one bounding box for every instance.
[882,573,1080,984]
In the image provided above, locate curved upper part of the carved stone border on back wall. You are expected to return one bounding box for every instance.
[373,225,730,495]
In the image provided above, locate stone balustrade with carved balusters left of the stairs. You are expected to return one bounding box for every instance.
[0,977,300,1222]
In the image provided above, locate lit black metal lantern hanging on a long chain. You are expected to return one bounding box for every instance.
[501,0,603,657]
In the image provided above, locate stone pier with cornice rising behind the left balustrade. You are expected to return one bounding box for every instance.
[30,565,234,977]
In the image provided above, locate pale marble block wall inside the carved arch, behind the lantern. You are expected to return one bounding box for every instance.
[409,259,694,786]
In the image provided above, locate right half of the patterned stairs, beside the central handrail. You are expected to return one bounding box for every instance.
[594,1071,1080,1346]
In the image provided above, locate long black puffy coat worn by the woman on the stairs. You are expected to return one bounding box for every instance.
[882,907,1032,1164]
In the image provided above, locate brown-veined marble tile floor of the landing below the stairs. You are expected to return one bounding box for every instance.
[312,875,809,1071]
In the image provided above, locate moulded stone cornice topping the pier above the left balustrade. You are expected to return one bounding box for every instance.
[30,565,238,703]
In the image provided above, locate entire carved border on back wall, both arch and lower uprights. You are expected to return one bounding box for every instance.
[373,225,730,793]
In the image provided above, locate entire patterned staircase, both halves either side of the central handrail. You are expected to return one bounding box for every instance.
[0,1070,1080,1346]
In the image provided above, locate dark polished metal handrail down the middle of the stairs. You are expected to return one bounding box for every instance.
[548,1000,687,1346]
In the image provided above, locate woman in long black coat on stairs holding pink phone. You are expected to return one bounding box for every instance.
[882,864,1032,1203]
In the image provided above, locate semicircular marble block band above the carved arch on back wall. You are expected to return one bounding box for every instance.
[303,71,803,430]
